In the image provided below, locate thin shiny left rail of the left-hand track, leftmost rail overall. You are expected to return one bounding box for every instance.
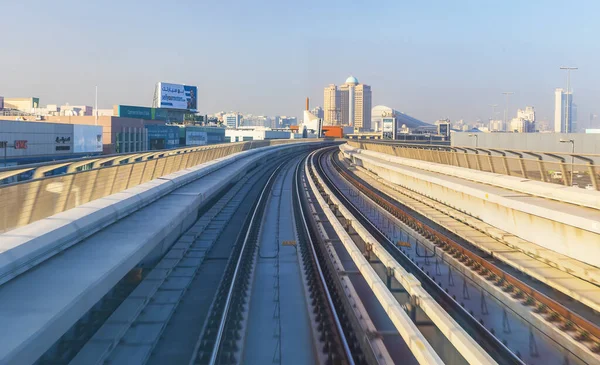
[209,162,285,365]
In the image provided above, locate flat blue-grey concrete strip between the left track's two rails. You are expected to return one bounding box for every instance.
[241,156,320,364]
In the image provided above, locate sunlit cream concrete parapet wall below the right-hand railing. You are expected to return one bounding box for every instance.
[340,145,600,267]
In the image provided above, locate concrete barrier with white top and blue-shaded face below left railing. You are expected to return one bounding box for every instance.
[0,145,318,284]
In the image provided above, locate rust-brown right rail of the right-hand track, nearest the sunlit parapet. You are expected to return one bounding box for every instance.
[333,146,600,353]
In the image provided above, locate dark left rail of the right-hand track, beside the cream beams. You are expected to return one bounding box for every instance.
[315,149,524,364]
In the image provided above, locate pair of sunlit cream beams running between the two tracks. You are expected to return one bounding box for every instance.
[307,149,502,364]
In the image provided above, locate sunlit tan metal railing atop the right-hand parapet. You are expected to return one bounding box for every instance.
[348,141,600,190]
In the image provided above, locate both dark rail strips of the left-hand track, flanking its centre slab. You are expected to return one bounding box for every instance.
[195,151,356,365]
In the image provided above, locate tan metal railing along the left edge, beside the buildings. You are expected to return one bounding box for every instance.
[0,140,307,232]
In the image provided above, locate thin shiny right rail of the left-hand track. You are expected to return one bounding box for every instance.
[294,157,354,365]
